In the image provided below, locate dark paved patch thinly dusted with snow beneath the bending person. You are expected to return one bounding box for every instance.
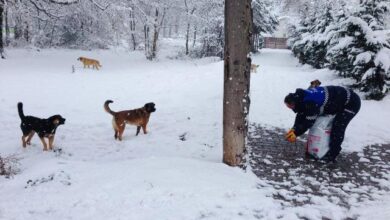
[248,125,390,219]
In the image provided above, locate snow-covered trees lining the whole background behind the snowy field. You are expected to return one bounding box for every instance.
[0,0,390,100]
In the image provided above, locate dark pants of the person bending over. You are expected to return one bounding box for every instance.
[326,91,361,161]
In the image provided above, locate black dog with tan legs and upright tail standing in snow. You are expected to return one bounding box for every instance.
[18,102,65,151]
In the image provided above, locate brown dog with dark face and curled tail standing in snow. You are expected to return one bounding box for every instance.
[104,100,156,141]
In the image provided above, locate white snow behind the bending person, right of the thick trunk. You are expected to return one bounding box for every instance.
[250,49,390,152]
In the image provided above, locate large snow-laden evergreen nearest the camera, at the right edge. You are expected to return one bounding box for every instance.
[328,0,390,100]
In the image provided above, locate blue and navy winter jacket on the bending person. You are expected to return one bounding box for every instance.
[293,86,351,136]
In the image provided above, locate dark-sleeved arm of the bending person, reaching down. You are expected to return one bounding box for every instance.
[292,103,320,136]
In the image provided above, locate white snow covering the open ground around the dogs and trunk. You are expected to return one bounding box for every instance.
[0,45,390,220]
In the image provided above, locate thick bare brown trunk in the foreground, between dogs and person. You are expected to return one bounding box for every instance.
[223,0,252,166]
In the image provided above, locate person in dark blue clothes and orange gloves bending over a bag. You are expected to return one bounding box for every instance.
[284,86,361,161]
